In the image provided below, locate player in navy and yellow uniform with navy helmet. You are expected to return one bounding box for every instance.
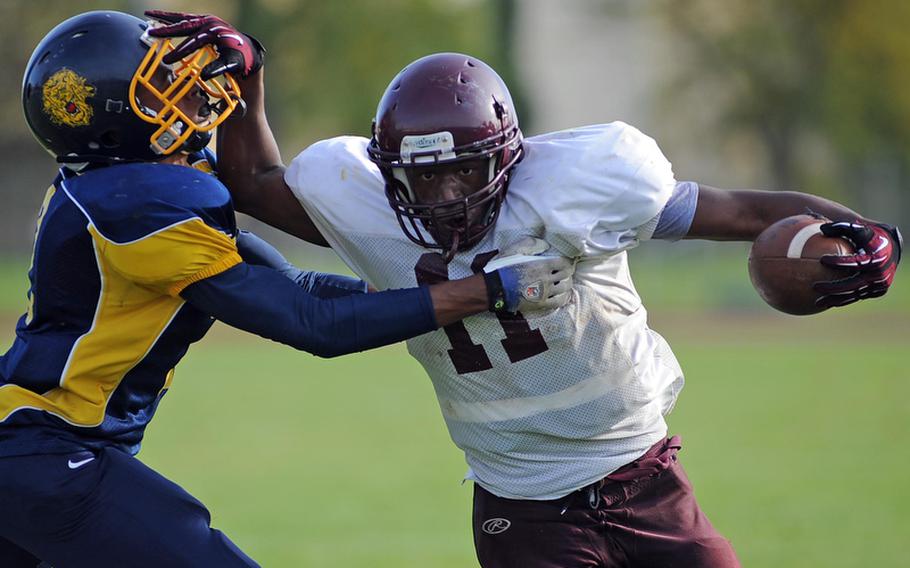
[0,11,572,568]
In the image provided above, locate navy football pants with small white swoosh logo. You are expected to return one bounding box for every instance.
[0,448,258,568]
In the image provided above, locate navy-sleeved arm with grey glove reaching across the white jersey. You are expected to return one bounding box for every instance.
[181,248,574,357]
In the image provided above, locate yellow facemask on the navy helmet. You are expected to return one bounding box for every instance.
[130,28,243,156]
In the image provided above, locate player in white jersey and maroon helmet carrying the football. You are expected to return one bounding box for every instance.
[157,11,900,568]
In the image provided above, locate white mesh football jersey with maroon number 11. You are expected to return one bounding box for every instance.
[285,122,683,499]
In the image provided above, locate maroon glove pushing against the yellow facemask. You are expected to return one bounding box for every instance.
[145,10,265,81]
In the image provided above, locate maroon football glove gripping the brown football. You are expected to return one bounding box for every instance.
[813,220,903,308]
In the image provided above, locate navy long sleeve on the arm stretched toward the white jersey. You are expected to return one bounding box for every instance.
[181,262,438,357]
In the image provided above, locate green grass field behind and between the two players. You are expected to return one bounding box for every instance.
[0,254,910,568]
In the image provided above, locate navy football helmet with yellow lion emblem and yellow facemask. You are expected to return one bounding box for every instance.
[22,11,241,169]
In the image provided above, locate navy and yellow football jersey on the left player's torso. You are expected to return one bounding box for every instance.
[0,153,241,456]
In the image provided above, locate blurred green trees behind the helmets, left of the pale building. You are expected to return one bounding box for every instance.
[0,0,520,252]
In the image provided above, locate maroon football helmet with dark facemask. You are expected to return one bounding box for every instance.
[368,53,522,260]
